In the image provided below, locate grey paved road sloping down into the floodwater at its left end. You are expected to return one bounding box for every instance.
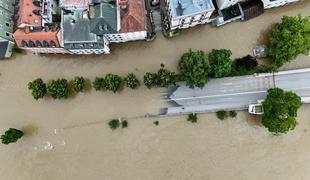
[160,68,310,115]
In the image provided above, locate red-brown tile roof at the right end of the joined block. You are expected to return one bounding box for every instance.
[120,0,146,33]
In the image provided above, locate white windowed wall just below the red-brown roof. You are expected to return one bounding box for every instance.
[105,31,147,43]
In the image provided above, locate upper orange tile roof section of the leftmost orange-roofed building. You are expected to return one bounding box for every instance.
[17,0,42,26]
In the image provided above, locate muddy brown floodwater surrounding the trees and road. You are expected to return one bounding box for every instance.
[0,1,310,180]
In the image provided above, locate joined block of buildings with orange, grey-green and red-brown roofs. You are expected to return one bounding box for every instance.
[14,0,147,54]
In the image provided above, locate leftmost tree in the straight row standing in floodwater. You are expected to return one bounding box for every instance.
[28,78,46,100]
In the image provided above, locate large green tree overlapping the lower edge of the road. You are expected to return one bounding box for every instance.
[262,88,302,133]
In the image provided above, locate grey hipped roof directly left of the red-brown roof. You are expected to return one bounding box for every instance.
[90,3,117,35]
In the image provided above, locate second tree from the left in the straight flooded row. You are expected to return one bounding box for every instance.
[47,79,69,99]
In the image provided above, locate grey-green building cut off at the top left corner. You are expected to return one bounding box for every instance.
[0,0,15,59]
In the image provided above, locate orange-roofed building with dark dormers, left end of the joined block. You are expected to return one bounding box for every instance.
[14,0,69,54]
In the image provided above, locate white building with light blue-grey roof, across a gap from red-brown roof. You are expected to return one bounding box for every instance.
[165,0,215,30]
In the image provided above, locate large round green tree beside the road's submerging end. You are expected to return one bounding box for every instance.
[179,50,210,88]
